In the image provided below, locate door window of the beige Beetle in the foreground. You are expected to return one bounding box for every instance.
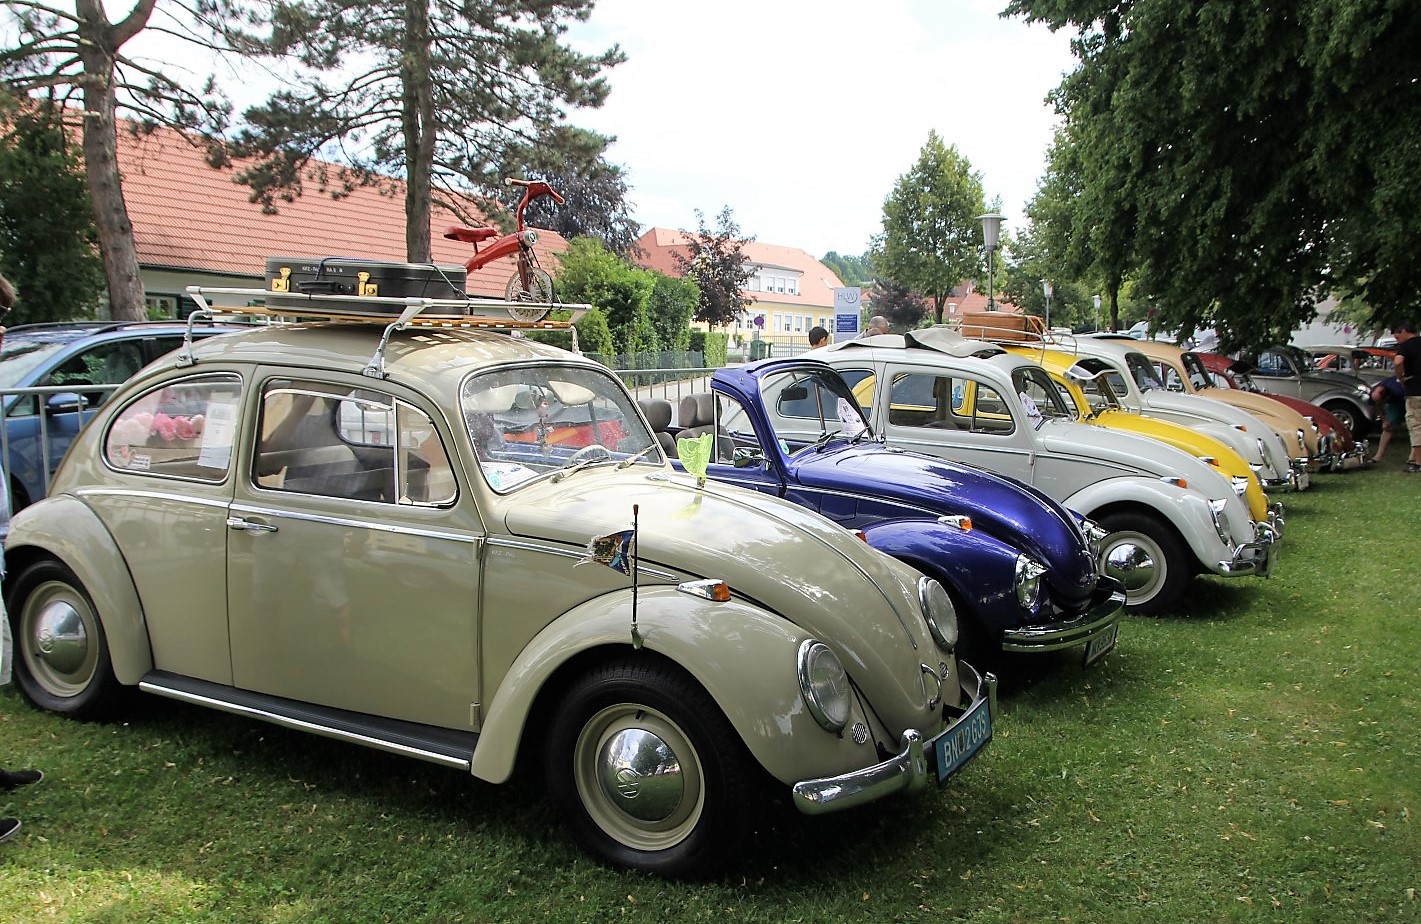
[252,380,437,505]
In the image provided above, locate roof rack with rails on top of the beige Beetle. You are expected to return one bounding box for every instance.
[178,286,593,378]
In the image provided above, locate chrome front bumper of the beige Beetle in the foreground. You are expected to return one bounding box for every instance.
[791,661,996,815]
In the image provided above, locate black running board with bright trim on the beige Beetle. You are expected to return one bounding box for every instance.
[138,671,479,773]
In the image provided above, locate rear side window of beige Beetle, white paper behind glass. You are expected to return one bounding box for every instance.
[104,375,242,482]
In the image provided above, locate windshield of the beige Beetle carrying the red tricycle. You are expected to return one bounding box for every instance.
[459,365,665,493]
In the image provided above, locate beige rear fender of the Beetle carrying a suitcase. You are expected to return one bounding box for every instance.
[4,495,153,685]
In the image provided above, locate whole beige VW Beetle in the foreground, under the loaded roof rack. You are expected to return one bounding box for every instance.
[6,324,995,876]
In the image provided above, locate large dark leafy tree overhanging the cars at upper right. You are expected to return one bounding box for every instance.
[1007,0,1421,347]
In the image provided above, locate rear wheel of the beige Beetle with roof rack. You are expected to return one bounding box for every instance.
[7,562,122,718]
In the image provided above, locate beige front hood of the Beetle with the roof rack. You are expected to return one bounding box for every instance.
[504,466,942,722]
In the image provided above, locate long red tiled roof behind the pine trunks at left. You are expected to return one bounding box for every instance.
[118,128,567,297]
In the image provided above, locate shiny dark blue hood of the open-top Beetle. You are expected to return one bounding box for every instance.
[790,444,1096,596]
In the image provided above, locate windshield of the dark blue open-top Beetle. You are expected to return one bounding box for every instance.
[760,370,872,453]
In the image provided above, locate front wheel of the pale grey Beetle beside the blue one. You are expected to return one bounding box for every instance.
[1097,512,1192,614]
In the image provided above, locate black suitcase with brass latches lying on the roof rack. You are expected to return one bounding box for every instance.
[266,257,469,316]
